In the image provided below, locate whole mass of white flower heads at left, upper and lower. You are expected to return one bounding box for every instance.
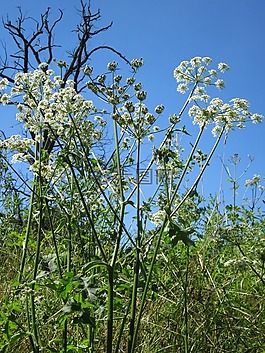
[0,63,108,180]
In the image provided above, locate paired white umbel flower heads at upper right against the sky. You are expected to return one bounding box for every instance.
[174,56,263,136]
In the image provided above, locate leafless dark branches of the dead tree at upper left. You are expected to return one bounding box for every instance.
[0,0,130,153]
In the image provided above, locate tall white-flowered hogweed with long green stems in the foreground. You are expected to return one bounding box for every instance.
[0,57,262,353]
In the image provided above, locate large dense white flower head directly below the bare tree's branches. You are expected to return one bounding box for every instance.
[9,69,94,135]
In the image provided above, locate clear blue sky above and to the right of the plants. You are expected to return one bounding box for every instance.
[0,0,265,205]
